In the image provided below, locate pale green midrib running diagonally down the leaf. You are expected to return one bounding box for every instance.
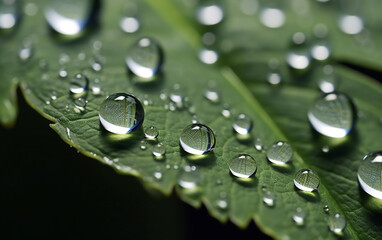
[145,0,358,239]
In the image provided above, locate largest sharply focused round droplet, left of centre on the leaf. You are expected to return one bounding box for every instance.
[99,93,145,134]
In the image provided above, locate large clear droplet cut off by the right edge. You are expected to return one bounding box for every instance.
[358,151,382,199]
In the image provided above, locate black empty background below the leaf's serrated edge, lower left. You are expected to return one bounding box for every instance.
[0,92,269,239]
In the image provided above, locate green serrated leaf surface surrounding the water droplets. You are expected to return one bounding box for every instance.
[0,0,382,239]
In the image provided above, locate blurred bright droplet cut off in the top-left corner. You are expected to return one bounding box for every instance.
[0,0,20,30]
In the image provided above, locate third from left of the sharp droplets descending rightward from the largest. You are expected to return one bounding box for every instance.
[229,154,257,178]
